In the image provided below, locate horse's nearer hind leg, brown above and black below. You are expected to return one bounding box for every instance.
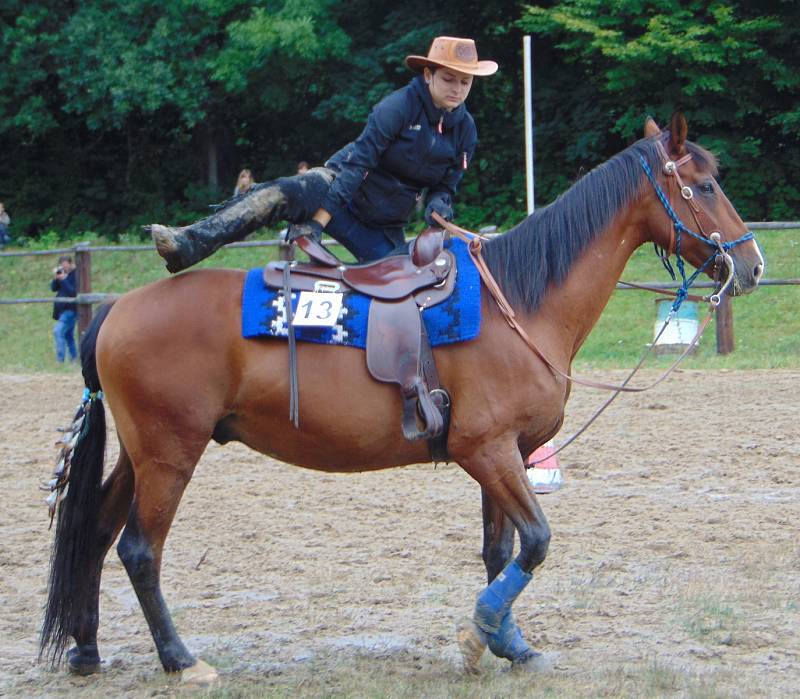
[117,440,208,672]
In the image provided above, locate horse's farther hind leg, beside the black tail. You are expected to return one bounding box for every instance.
[67,444,133,675]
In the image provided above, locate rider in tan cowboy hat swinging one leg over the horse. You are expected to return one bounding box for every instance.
[150,36,497,272]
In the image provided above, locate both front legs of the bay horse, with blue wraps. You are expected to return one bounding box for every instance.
[458,447,550,672]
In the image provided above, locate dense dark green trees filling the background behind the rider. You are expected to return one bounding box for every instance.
[0,0,800,236]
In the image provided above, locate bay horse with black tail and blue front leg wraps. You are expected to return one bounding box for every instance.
[40,115,764,680]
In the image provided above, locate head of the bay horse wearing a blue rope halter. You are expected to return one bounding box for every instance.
[642,114,764,295]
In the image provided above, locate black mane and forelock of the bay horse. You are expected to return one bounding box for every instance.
[483,133,716,312]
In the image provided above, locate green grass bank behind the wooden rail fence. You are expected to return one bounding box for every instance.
[0,230,800,373]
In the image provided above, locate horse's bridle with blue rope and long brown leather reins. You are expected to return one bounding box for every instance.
[433,141,754,466]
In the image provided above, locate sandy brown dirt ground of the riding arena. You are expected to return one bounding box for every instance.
[0,371,800,696]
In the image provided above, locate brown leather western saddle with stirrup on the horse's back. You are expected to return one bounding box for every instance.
[264,228,456,452]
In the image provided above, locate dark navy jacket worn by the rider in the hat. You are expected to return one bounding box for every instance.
[322,76,478,227]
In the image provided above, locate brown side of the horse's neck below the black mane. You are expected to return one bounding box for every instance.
[532,215,644,361]
